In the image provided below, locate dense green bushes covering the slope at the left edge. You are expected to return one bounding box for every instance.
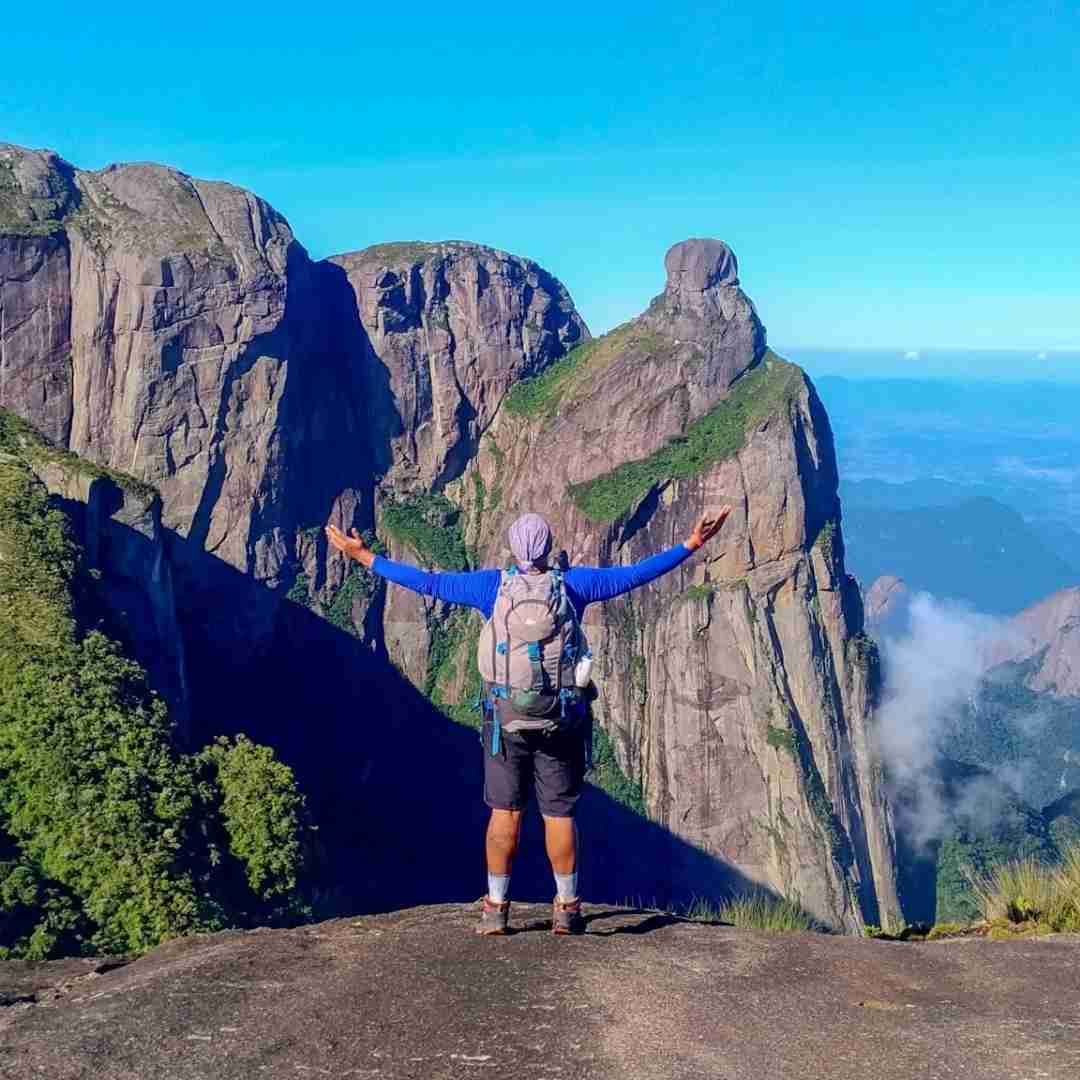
[0,444,313,958]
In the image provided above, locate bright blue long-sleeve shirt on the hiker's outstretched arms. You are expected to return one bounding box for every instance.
[372,543,692,621]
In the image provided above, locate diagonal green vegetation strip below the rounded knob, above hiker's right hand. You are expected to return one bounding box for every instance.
[569,353,802,522]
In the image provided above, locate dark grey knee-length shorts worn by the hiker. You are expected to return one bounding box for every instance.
[483,716,588,818]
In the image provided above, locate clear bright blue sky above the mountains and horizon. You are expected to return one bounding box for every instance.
[0,0,1080,352]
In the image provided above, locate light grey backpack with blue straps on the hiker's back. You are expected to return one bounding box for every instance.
[476,568,589,731]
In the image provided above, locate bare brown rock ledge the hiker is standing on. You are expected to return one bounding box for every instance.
[0,905,1080,1080]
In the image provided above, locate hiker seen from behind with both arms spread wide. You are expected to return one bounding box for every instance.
[326,507,731,934]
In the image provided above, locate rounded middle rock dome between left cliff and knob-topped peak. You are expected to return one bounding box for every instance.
[329,242,589,491]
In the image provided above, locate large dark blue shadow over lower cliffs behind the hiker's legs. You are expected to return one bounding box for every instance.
[141,534,751,914]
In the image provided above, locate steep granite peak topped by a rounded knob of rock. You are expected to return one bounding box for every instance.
[432,241,899,928]
